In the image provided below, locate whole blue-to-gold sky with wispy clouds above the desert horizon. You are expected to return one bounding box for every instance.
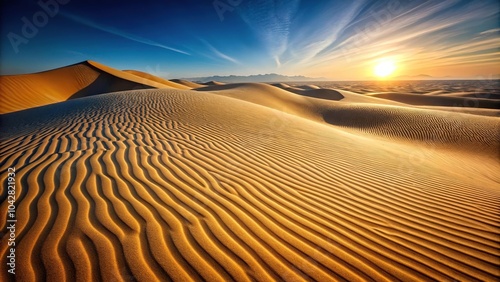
[0,0,500,80]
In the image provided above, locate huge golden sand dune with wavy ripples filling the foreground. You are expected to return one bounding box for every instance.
[0,62,500,281]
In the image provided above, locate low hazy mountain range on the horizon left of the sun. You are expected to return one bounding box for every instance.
[183,73,330,83]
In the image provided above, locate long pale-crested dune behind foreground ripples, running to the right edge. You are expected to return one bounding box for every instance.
[197,83,500,154]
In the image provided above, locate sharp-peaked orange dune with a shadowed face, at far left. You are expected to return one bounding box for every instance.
[0,61,176,114]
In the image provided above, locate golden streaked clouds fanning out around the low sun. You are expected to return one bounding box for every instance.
[289,0,500,78]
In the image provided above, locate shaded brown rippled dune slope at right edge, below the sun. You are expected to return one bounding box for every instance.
[323,104,500,155]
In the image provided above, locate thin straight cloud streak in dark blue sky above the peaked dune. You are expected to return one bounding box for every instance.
[61,12,191,55]
